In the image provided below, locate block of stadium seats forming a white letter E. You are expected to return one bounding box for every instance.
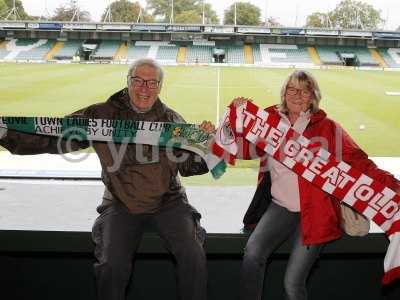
[254,44,313,65]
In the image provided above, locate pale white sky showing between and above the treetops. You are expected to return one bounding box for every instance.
[18,0,400,30]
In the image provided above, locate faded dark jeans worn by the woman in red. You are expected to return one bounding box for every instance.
[240,202,323,300]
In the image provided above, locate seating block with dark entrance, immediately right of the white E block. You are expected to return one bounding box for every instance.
[317,46,379,67]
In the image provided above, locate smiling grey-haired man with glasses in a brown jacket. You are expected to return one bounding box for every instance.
[0,59,215,300]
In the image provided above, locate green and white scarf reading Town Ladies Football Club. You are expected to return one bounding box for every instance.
[0,117,226,178]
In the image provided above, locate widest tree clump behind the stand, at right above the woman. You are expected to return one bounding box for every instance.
[306,0,383,30]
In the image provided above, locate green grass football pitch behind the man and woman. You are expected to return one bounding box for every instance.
[0,64,400,184]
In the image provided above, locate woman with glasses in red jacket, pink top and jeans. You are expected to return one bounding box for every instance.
[233,70,400,300]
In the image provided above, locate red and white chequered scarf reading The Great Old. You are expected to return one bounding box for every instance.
[213,102,400,284]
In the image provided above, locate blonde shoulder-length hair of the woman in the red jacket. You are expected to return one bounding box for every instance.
[279,70,322,113]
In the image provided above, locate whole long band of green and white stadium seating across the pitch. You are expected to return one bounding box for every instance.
[0,38,394,68]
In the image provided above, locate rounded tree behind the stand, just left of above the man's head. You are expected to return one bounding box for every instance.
[101,0,152,23]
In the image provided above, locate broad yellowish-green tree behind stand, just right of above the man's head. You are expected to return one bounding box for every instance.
[147,0,218,24]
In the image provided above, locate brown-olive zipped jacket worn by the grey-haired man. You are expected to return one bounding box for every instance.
[0,88,208,213]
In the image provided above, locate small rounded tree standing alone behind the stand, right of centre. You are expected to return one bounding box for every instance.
[224,2,261,25]
